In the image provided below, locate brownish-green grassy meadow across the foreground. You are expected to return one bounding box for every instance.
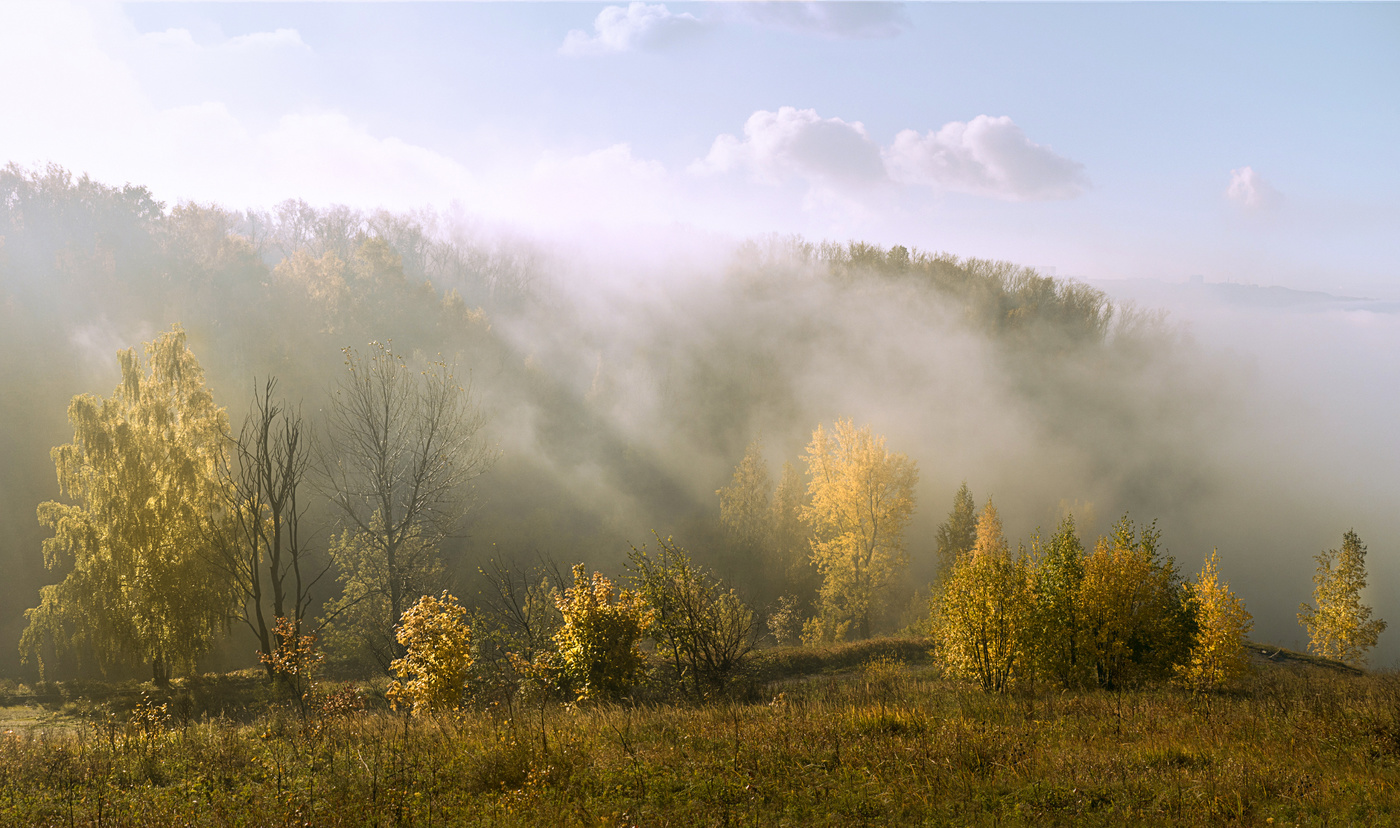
[0,643,1400,828]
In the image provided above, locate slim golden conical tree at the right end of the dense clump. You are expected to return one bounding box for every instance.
[1176,551,1254,691]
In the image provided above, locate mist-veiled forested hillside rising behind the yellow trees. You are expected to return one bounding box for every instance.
[0,165,1231,675]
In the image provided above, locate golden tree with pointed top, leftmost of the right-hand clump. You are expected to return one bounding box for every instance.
[935,500,1032,692]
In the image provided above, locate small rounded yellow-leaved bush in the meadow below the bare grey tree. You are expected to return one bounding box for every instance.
[388,591,473,713]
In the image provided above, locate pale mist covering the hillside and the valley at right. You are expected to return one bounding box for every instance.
[0,165,1400,675]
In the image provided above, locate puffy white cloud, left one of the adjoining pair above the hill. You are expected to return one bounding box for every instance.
[692,106,885,188]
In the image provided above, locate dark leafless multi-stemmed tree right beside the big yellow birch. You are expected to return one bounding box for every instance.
[217,378,329,679]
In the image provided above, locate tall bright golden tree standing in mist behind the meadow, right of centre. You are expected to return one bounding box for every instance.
[802,419,918,643]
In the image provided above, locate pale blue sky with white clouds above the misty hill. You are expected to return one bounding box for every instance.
[0,0,1400,298]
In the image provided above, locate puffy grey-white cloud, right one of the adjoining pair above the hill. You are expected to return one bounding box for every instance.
[885,115,1088,202]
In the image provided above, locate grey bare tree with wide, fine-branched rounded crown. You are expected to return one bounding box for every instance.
[319,342,496,661]
